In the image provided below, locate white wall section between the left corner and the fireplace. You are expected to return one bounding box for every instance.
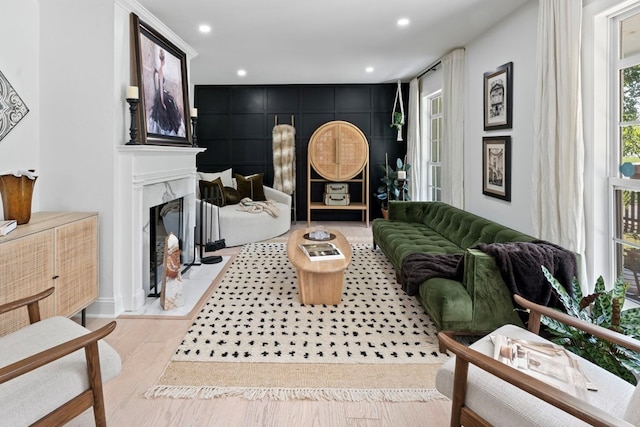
[40,0,125,314]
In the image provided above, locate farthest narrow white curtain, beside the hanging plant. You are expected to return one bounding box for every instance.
[407,78,427,200]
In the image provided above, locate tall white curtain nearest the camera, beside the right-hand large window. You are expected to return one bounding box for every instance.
[532,0,585,253]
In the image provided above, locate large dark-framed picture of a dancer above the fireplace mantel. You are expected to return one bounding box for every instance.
[131,13,192,146]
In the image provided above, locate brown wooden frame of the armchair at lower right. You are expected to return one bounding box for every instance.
[438,295,640,427]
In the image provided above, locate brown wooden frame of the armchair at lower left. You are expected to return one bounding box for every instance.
[0,288,116,426]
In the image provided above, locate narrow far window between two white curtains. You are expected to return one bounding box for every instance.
[422,91,442,201]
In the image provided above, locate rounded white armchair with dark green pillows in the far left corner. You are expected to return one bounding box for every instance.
[196,179,291,246]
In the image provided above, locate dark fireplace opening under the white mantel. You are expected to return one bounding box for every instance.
[149,197,184,297]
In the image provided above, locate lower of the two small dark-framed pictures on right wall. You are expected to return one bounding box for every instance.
[482,136,511,202]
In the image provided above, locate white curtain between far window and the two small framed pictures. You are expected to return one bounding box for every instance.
[442,49,465,209]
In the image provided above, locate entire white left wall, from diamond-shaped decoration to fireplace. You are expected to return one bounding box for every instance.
[0,0,196,317]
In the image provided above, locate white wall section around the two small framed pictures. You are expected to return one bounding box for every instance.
[464,0,538,235]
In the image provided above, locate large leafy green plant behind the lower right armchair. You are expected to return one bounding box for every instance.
[540,266,640,385]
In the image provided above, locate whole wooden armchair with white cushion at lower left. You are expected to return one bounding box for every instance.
[0,288,122,426]
